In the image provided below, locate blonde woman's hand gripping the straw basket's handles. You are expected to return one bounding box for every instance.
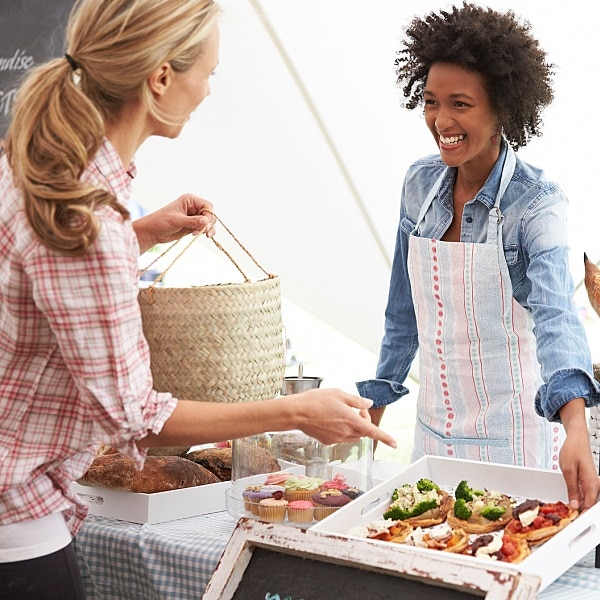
[133,194,217,254]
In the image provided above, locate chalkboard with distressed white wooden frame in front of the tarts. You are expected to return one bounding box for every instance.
[203,519,540,600]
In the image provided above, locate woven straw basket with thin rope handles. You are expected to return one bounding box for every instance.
[139,213,285,402]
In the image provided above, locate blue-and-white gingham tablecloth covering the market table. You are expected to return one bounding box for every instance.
[76,512,600,600]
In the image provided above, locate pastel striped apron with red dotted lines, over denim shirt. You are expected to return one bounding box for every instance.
[408,149,563,470]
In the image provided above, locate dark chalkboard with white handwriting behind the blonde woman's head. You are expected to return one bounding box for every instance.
[0,0,73,140]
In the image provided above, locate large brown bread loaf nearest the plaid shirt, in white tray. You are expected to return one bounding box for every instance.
[78,454,220,494]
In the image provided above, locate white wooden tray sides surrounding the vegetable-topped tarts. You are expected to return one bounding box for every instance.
[311,456,600,590]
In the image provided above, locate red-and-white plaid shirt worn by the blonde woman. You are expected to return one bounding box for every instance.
[0,141,177,533]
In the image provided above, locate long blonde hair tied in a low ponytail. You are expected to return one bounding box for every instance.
[6,0,220,255]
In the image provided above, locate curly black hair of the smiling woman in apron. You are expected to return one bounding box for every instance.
[394,2,554,150]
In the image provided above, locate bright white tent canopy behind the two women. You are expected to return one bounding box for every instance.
[134,0,600,390]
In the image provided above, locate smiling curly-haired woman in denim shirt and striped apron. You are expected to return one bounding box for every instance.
[357,3,600,508]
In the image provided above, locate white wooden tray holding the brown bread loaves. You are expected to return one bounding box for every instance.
[71,481,231,523]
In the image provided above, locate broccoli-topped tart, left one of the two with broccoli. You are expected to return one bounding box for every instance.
[383,479,454,527]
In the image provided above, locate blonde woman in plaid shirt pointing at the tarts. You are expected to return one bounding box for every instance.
[0,0,395,600]
